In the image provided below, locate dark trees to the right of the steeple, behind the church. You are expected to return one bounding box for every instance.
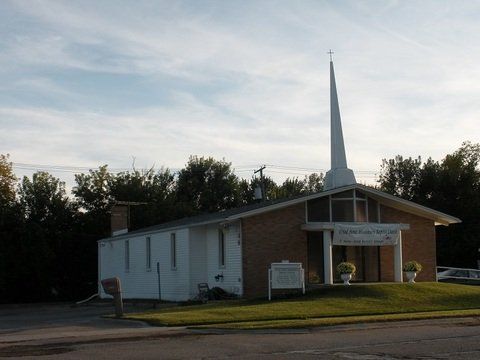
[380,142,480,267]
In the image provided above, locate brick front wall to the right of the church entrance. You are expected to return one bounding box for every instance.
[380,205,437,281]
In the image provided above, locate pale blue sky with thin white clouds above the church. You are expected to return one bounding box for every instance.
[0,0,480,190]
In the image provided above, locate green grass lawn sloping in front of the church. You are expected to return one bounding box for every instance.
[125,283,480,328]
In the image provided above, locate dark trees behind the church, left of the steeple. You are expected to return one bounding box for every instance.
[0,155,323,302]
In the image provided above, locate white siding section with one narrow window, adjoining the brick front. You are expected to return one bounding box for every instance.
[207,222,243,295]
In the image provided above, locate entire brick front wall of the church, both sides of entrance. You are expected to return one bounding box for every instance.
[242,203,436,298]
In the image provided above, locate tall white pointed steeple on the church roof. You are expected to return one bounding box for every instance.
[323,51,357,190]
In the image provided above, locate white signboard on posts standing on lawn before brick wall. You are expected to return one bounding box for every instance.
[268,261,305,300]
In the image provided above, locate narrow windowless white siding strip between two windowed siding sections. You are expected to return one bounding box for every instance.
[190,226,208,298]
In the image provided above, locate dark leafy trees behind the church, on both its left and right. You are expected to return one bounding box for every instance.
[0,142,480,302]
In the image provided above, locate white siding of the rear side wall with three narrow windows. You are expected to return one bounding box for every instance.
[99,229,190,301]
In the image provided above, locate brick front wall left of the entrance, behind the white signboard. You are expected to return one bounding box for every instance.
[242,203,307,298]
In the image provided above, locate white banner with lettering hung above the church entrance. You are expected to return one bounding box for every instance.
[332,223,400,246]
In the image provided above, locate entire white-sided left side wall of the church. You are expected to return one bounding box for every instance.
[98,221,243,301]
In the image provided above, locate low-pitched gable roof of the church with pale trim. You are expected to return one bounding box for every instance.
[99,184,461,241]
